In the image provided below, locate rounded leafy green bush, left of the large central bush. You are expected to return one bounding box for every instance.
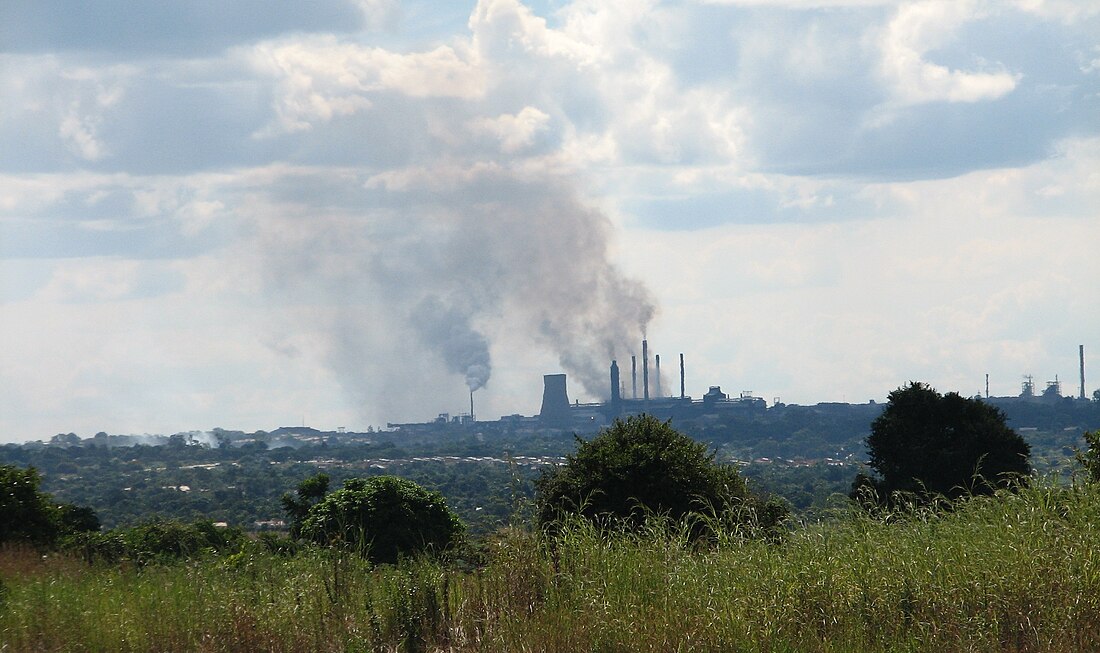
[300,476,465,563]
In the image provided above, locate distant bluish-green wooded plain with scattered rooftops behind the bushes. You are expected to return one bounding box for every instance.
[8,391,1100,527]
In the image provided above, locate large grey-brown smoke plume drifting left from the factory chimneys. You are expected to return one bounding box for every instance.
[255,165,655,414]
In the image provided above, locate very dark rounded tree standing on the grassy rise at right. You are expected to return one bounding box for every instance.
[853,381,1031,501]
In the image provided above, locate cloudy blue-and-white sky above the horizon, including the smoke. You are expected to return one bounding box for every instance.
[0,0,1100,442]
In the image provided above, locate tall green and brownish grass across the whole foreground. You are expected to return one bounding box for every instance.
[0,484,1100,652]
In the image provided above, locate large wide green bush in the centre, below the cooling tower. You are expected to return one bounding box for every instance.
[536,414,787,534]
